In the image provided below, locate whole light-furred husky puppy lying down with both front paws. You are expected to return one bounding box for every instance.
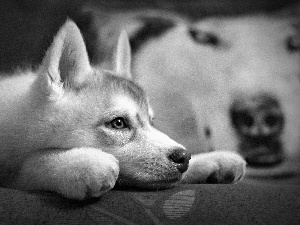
[0,20,245,200]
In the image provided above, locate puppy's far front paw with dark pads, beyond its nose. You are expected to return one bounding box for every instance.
[182,151,246,184]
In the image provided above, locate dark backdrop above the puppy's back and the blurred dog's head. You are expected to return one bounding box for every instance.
[0,0,298,72]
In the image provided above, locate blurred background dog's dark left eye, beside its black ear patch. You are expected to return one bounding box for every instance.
[189,28,220,46]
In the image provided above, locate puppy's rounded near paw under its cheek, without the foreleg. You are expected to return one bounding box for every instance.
[58,148,119,200]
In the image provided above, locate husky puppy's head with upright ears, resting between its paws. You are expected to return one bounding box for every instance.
[31,21,190,188]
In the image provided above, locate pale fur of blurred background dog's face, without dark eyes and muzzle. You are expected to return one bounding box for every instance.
[96,7,300,182]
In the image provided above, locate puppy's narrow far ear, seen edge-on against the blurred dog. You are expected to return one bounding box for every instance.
[115,30,132,79]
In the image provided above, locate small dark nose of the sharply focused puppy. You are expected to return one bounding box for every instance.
[169,148,191,173]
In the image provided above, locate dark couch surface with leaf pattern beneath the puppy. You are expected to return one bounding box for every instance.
[0,182,300,225]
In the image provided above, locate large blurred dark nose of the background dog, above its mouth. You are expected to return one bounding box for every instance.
[230,94,284,138]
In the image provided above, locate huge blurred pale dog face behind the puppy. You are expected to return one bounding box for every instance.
[95,6,300,183]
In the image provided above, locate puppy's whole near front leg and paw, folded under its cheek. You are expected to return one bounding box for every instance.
[13,148,119,200]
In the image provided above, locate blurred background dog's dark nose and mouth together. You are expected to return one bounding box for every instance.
[230,93,285,167]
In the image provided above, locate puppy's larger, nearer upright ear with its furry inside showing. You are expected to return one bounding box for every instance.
[39,20,92,98]
